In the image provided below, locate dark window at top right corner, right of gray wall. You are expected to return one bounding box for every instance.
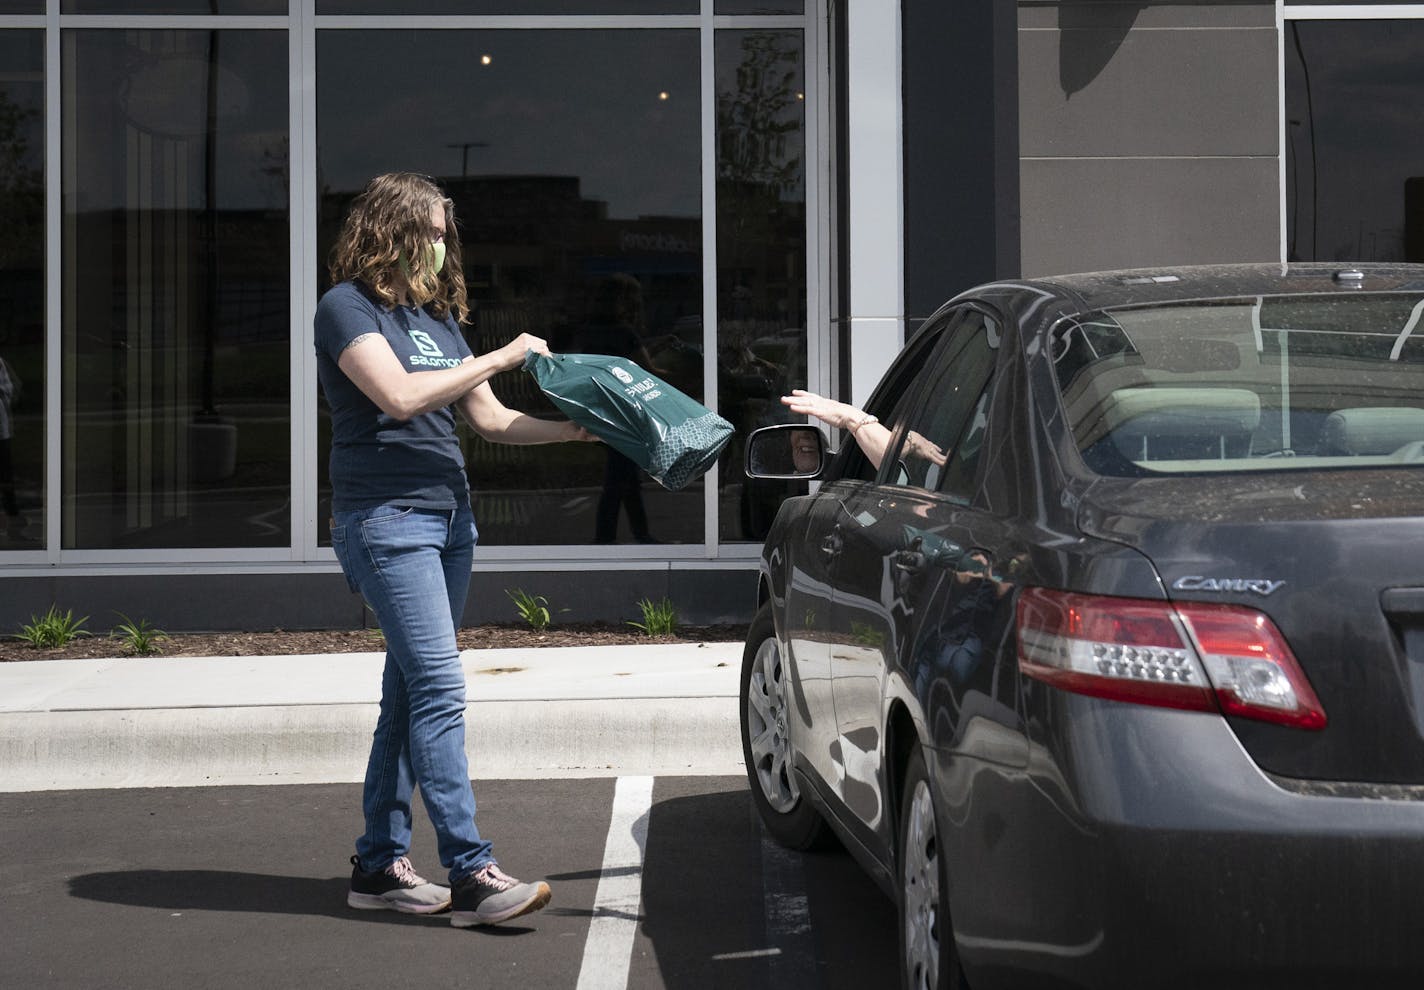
[1284,20,1424,261]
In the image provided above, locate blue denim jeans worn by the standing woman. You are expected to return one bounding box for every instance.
[332,506,493,883]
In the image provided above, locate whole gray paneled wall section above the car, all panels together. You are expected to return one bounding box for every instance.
[1018,3,1280,275]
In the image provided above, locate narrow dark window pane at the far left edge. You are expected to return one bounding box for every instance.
[0,31,44,551]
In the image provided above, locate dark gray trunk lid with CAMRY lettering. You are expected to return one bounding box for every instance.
[1081,470,1424,785]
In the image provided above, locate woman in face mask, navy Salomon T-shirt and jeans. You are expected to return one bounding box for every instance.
[316,174,594,927]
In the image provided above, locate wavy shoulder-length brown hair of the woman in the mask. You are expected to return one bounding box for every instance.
[328,172,470,323]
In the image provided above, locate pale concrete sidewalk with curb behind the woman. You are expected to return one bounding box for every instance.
[0,642,743,791]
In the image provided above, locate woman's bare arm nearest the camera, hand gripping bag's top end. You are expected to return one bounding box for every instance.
[336,330,548,422]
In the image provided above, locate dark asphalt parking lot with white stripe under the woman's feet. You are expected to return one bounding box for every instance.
[0,776,896,990]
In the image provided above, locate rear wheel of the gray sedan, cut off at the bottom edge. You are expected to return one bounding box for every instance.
[896,746,968,990]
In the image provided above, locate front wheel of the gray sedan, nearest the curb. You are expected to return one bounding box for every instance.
[742,603,826,849]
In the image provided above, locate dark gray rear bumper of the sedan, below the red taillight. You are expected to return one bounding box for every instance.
[934,692,1424,990]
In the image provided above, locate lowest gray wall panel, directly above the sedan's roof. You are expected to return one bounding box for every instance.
[1022,158,1280,276]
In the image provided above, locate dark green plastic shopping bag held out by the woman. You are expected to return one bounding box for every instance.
[524,350,732,491]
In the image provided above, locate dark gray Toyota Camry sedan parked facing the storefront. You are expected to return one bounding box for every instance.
[742,265,1424,990]
